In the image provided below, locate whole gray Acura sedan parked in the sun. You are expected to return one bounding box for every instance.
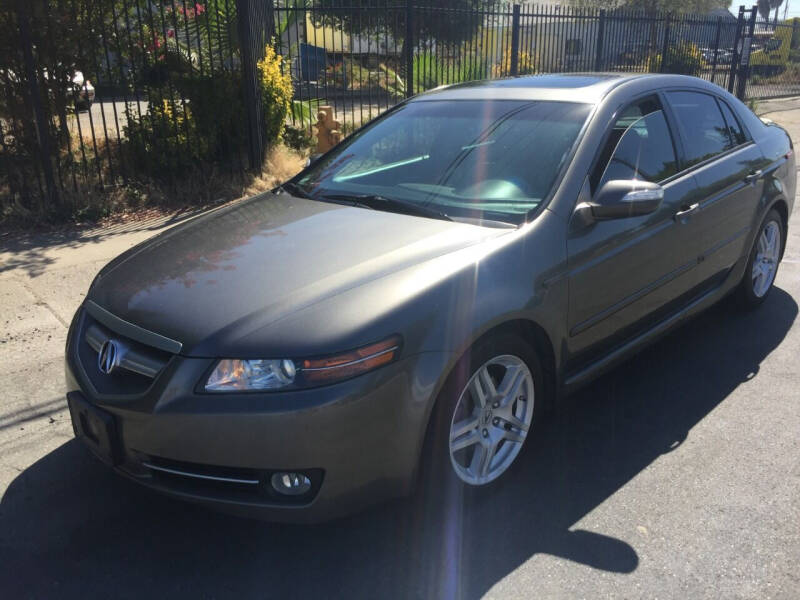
[66,74,796,521]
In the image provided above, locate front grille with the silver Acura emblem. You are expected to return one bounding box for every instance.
[75,311,174,396]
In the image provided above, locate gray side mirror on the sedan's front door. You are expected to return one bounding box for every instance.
[578,179,664,221]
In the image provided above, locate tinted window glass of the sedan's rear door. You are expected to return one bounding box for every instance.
[667,92,732,167]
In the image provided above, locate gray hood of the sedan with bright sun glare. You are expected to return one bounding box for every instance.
[88,193,509,356]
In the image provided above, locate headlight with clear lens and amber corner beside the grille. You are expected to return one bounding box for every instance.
[205,335,400,392]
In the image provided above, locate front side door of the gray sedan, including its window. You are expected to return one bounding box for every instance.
[567,95,697,366]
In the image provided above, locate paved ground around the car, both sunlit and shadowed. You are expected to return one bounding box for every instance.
[0,101,800,599]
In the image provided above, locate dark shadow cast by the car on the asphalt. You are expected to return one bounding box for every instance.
[0,288,798,598]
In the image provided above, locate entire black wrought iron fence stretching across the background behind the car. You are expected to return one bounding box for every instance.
[0,0,800,218]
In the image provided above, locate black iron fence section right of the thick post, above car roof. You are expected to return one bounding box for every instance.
[275,0,760,132]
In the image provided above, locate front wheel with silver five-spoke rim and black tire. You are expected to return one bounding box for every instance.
[420,333,546,495]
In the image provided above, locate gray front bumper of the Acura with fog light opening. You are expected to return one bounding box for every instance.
[66,344,448,522]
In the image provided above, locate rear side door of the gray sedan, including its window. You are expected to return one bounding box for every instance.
[665,90,769,285]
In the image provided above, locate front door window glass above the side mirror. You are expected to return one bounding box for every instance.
[590,98,678,192]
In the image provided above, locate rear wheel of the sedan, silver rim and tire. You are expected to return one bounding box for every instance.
[737,209,786,309]
